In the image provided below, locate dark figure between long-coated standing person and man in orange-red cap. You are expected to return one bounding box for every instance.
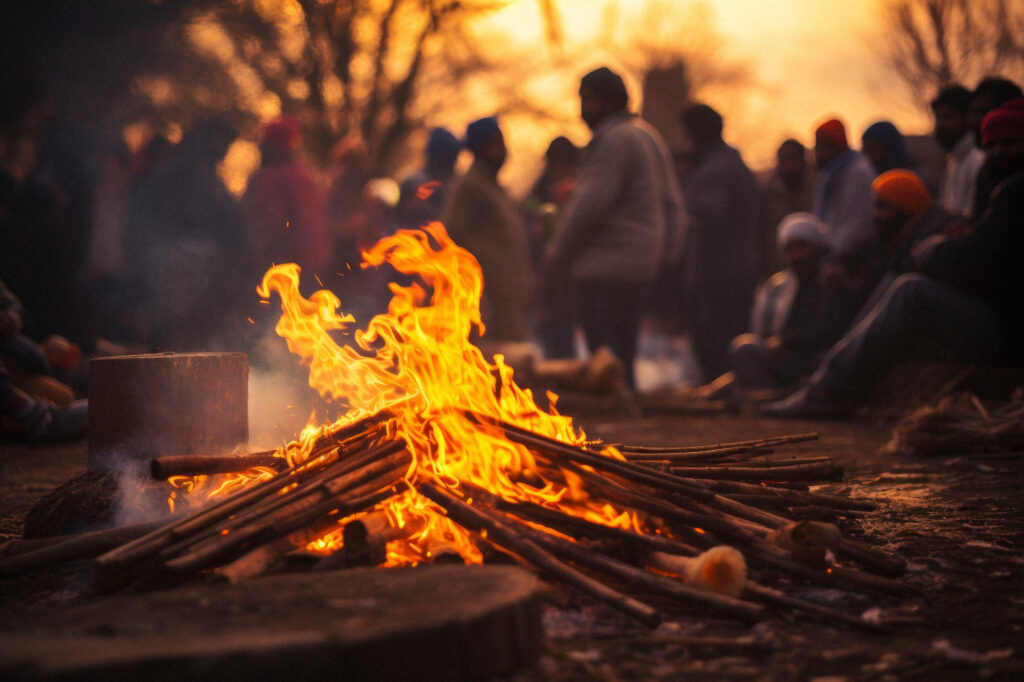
[759,138,814,280]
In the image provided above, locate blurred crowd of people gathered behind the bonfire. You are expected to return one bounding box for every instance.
[0,68,1024,439]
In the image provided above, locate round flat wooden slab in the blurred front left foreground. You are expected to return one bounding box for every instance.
[0,565,543,682]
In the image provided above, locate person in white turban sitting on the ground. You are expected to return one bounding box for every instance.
[698,212,859,397]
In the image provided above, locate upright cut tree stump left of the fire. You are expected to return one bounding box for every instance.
[88,353,249,471]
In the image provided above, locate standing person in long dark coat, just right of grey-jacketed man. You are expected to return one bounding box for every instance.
[682,104,760,377]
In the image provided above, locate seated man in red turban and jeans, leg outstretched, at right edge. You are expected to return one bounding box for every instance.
[764,98,1024,419]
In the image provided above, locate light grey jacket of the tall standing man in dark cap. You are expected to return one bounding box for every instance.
[547,112,686,284]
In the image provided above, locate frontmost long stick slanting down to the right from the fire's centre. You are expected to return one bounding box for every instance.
[417,483,662,628]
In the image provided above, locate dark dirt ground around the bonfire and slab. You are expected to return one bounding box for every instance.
[0,405,1024,682]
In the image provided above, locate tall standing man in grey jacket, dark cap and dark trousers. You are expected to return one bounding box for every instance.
[542,67,685,388]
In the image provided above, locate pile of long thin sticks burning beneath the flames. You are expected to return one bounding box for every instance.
[0,412,908,629]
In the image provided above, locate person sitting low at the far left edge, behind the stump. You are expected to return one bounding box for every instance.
[0,282,88,441]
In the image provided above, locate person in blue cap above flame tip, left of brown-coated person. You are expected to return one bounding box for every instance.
[395,127,462,227]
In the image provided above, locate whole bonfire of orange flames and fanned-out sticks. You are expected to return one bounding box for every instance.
[86,223,902,625]
